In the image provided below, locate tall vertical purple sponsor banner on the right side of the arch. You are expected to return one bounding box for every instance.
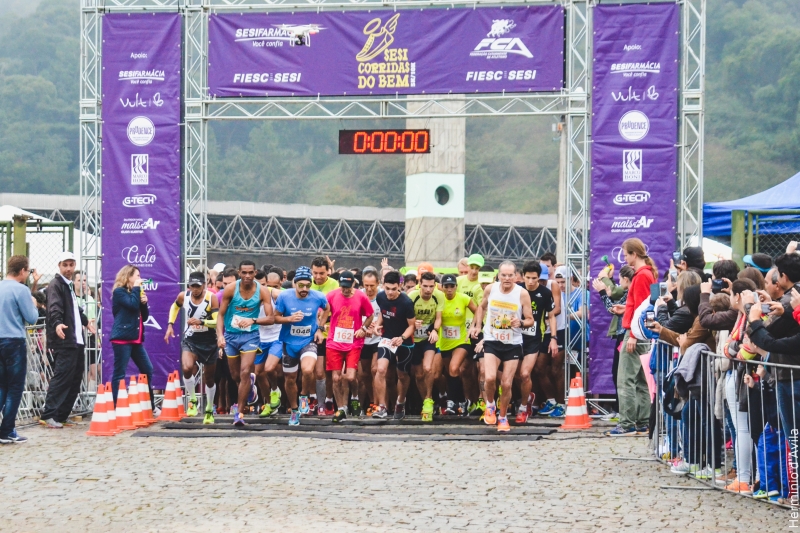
[589,3,680,394]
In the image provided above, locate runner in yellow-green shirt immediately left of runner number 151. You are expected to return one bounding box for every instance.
[408,272,447,422]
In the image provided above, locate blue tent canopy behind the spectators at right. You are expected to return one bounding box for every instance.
[703,173,800,237]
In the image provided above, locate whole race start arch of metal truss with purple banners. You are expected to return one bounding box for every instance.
[80,0,706,400]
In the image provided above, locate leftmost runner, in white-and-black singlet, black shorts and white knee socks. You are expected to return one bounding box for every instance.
[164,272,219,424]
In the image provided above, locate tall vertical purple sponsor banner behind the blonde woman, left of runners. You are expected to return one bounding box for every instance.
[102,14,181,389]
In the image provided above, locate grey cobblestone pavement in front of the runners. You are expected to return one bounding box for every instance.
[0,423,790,533]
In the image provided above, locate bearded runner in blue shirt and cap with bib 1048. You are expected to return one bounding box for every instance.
[275,266,328,426]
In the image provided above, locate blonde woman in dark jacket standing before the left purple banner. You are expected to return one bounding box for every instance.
[111,265,160,416]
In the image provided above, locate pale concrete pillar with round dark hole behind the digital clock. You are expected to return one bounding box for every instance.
[405,95,467,267]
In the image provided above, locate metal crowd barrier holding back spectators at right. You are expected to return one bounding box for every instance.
[650,342,800,512]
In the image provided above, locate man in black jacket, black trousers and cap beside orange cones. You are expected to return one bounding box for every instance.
[39,252,94,429]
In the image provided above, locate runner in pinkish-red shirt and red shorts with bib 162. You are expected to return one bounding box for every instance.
[325,270,373,422]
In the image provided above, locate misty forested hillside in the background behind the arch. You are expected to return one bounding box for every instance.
[0,0,800,213]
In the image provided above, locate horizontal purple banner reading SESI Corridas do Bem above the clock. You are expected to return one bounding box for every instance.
[208,6,564,97]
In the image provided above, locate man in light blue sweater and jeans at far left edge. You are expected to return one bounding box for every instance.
[0,255,39,444]
